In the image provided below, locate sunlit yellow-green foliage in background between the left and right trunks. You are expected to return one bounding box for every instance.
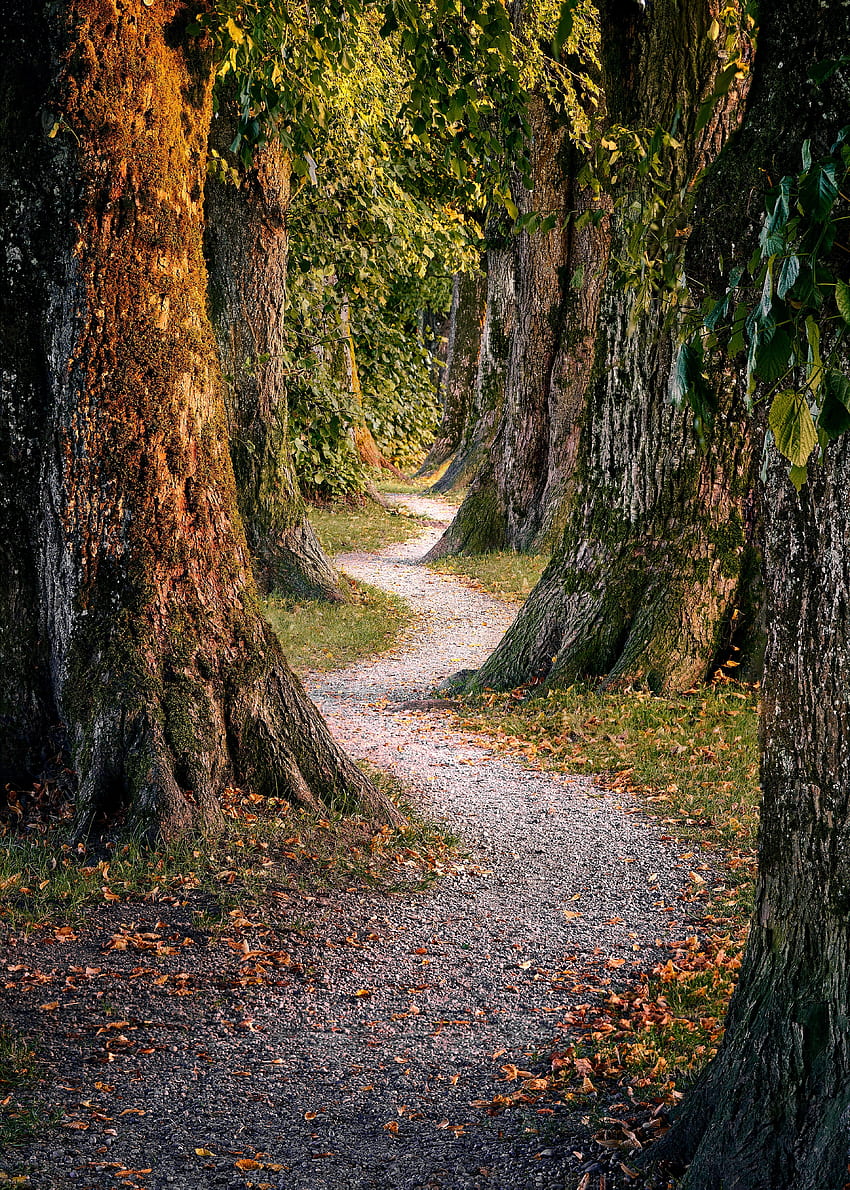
[275,15,480,499]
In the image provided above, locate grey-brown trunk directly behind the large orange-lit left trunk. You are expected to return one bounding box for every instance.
[205,102,344,601]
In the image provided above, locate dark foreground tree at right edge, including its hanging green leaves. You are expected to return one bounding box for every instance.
[652,0,850,1190]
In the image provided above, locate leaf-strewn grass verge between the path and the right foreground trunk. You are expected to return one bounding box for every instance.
[450,682,760,1109]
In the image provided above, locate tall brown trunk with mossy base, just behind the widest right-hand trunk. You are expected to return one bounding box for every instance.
[423,2,607,557]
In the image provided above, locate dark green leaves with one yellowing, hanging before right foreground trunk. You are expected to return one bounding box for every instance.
[673,126,850,489]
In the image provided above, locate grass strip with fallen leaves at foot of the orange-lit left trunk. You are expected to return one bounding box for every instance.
[0,769,457,929]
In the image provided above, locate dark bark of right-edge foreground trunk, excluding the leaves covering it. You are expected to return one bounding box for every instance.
[650,0,850,1190]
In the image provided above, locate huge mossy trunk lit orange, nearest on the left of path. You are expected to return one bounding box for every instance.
[0,0,395,835]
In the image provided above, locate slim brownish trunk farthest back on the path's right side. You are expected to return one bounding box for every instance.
[417,270,487,476]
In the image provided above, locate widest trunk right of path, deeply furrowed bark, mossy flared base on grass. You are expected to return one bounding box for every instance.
[457,0,755,690]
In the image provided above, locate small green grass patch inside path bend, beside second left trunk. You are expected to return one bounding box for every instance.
[264,583,413,674]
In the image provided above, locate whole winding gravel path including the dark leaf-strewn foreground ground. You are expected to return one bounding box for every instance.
[0,496,699,1190]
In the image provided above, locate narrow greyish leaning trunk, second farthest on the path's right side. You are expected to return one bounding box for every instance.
[431,219,517,493]
